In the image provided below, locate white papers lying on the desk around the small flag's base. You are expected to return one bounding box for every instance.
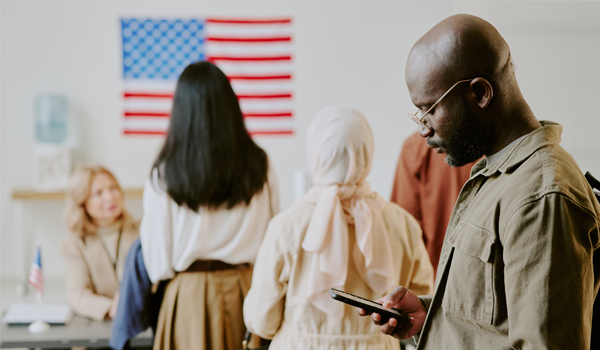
[2,303,73,325]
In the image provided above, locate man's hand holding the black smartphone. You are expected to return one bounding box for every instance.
[357,286,427,340]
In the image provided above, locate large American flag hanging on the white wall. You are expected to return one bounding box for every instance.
[121,18,294,134]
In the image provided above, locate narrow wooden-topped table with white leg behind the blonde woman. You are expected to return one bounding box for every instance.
[11,188,144,295]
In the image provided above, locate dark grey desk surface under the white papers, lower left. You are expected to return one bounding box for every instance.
[0,316,152,349]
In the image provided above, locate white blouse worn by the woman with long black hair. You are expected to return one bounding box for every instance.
[140,166,279,283]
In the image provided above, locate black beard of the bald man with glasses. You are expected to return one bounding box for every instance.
[427,98,488,167]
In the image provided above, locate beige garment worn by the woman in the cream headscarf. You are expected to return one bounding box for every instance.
[244,203,433,350]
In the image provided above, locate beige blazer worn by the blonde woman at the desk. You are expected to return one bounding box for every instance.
[60,219,139,320]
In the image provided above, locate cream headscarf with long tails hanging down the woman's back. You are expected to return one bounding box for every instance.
[299,106,397,319]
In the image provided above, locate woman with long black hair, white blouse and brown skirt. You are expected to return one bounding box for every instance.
[140,62,279,350]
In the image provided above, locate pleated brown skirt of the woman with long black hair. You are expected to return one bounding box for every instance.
[153,267,252,350]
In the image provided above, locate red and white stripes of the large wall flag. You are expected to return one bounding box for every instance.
[123,18,294,134]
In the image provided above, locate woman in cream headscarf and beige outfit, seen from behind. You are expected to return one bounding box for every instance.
[244,106,433,350]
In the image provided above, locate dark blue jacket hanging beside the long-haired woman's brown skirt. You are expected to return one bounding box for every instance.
[109,239,166,350]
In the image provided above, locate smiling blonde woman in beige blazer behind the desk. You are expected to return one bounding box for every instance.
[60,165,139,320]
